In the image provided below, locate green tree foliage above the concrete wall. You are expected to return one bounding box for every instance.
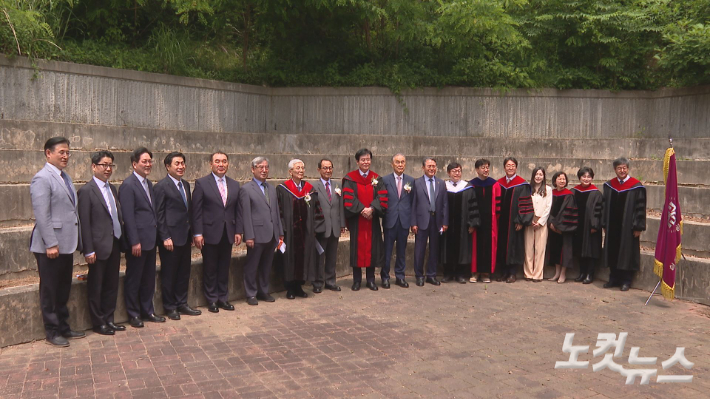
[0,0,710,92]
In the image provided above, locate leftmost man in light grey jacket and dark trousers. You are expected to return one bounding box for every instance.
[30,137,86,346]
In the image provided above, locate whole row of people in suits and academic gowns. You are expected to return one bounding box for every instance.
[30,137,646,346]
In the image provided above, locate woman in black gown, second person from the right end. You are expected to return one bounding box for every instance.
[572,166,602,284]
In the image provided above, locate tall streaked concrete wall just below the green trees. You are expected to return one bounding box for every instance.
[0,58,710,138]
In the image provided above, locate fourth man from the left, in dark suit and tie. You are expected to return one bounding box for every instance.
[155,152,202,320]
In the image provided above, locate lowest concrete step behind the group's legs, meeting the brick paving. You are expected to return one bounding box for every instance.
[0,239,710,347]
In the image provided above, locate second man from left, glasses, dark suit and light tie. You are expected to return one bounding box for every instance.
[79,151,126,335]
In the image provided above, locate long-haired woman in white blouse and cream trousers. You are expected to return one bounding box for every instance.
[523,166,552,283]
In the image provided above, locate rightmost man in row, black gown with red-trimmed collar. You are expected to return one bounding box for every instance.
[601,158,646,291]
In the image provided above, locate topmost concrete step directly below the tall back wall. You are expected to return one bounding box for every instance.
[0,119,710,160]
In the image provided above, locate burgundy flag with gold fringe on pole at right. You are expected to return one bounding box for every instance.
[653,148,683,299]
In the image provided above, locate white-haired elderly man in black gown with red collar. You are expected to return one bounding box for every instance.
[276,159,323,299]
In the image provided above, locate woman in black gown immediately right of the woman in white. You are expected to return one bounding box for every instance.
[547,172,577,283]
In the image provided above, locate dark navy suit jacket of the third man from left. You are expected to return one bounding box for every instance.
[118,173,158,252]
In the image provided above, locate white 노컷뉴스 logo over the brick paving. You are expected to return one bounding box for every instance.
[555,332,694,385]
